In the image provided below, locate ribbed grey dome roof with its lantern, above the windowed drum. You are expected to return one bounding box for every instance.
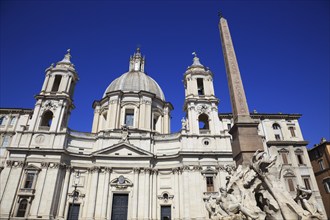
[103,48,165,101]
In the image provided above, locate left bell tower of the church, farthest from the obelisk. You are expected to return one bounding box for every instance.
[29,49,79,132]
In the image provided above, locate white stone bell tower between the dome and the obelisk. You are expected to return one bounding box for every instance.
[183,52,220,134]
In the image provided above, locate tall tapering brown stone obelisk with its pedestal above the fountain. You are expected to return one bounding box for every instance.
[219,16,263,165]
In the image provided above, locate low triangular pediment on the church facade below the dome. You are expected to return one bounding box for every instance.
[93,143,153,157]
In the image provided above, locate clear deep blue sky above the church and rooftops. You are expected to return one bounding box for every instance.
[0,0,330,146]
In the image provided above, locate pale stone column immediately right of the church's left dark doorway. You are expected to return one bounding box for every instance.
[86,167,99,219]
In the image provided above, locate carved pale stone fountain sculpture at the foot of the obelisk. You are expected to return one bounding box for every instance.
[204,150,326,220]
